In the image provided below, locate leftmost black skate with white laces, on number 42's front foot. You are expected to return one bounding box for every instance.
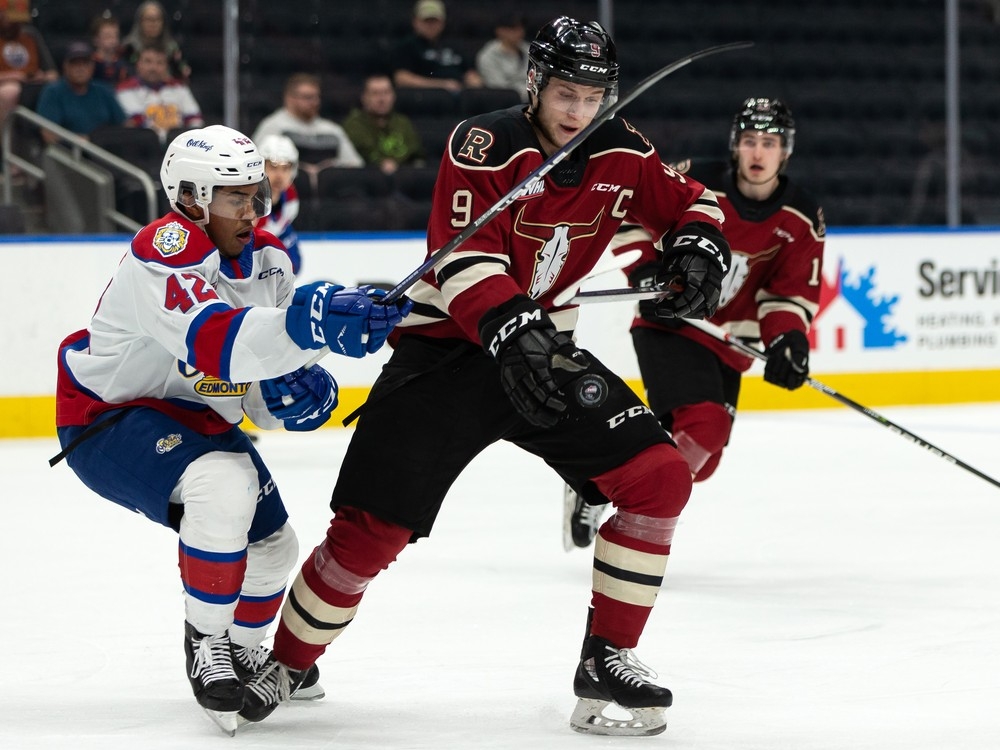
[184,622,243,736]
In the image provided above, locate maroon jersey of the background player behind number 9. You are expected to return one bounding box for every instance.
[628,162,826,372]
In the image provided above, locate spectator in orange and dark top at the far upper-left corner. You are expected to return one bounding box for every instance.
[0,0,59,124]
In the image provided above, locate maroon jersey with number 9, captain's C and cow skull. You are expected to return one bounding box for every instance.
[397,107,722,343]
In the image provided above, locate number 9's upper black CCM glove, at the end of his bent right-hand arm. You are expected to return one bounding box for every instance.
[654,221,731,318]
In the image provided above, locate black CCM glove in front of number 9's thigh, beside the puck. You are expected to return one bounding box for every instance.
[479,295,590,427]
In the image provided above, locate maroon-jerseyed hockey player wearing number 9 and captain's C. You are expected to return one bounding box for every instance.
[243,17,729,734]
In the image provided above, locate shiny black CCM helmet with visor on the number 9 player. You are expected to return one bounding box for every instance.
[528,16,618,111]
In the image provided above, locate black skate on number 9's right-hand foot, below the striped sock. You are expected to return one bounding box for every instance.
[569,635,673,736]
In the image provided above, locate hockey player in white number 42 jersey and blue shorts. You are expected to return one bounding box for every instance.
[53,125,410,734]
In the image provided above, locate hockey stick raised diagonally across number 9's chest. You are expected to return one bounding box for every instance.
[381,42,753,304]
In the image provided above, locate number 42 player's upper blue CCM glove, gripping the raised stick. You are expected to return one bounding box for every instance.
[285,281,413,358]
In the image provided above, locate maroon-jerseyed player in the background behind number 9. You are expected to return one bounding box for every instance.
[564,97,826,547]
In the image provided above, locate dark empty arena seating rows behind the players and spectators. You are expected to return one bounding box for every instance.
[34,0,1000,229]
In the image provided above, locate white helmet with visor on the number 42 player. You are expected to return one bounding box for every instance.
[160,125,271,224]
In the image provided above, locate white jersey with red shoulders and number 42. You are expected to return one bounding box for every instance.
[56,214,315,434]
